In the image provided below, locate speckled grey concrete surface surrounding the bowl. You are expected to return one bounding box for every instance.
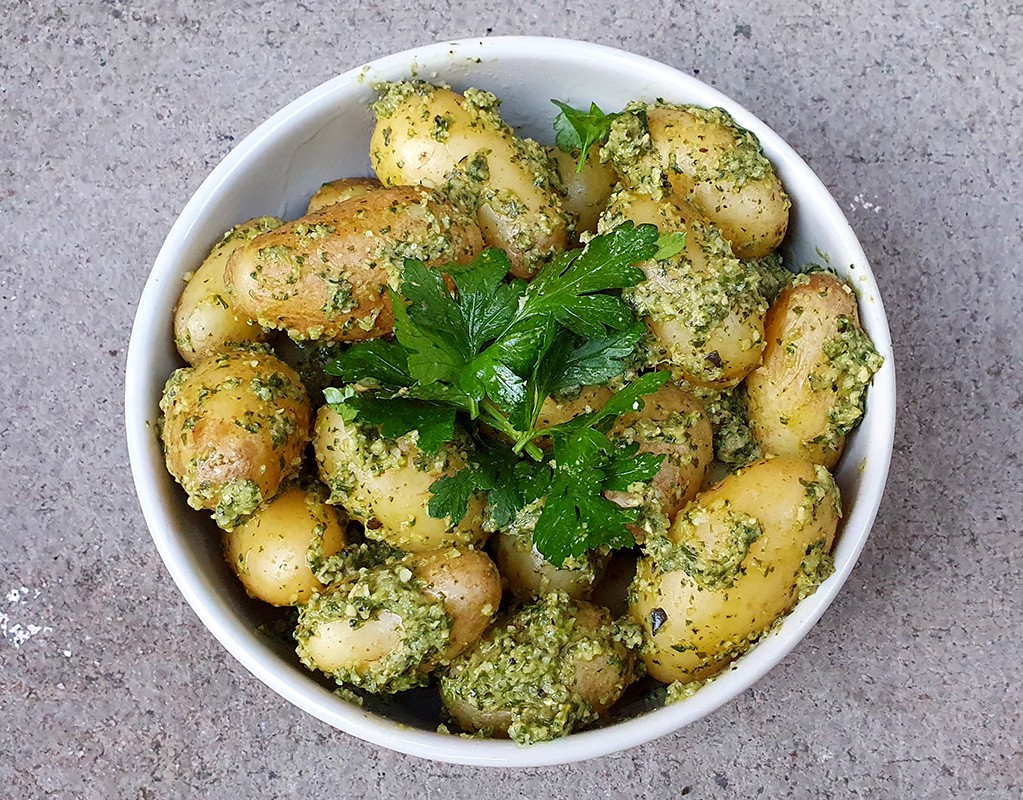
[0,0,1023,800]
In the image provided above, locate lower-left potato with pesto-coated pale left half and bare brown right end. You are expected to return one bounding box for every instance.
[296,548,501,693]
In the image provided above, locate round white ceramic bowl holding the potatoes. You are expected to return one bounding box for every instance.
[125,37,895,766]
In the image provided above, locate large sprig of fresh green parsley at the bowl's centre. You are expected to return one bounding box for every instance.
[326,222,666,564]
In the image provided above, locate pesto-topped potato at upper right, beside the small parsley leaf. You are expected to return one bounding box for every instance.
[604,102,792,259]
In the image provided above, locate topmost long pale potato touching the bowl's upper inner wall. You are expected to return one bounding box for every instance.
[369,81,569,277]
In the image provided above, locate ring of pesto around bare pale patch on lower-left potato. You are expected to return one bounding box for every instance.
[295,548,451,694]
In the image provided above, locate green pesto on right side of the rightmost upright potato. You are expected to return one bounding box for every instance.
[810,316,884,445]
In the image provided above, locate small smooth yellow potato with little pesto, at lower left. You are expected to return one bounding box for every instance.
[224,486,348,606]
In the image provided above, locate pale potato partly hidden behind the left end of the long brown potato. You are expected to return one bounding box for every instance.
[174,212,284,366]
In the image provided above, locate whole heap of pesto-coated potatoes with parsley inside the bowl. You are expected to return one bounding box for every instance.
[155,80,881,745]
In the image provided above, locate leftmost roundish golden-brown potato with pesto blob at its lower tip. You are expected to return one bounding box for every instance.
[160,347,312,530]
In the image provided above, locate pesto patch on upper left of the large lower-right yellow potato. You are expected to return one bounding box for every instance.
[643,504,763,590]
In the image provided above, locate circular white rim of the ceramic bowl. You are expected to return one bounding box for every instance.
[125,36,895,766]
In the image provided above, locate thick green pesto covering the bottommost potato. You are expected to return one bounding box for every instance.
[441,592,641,745]
